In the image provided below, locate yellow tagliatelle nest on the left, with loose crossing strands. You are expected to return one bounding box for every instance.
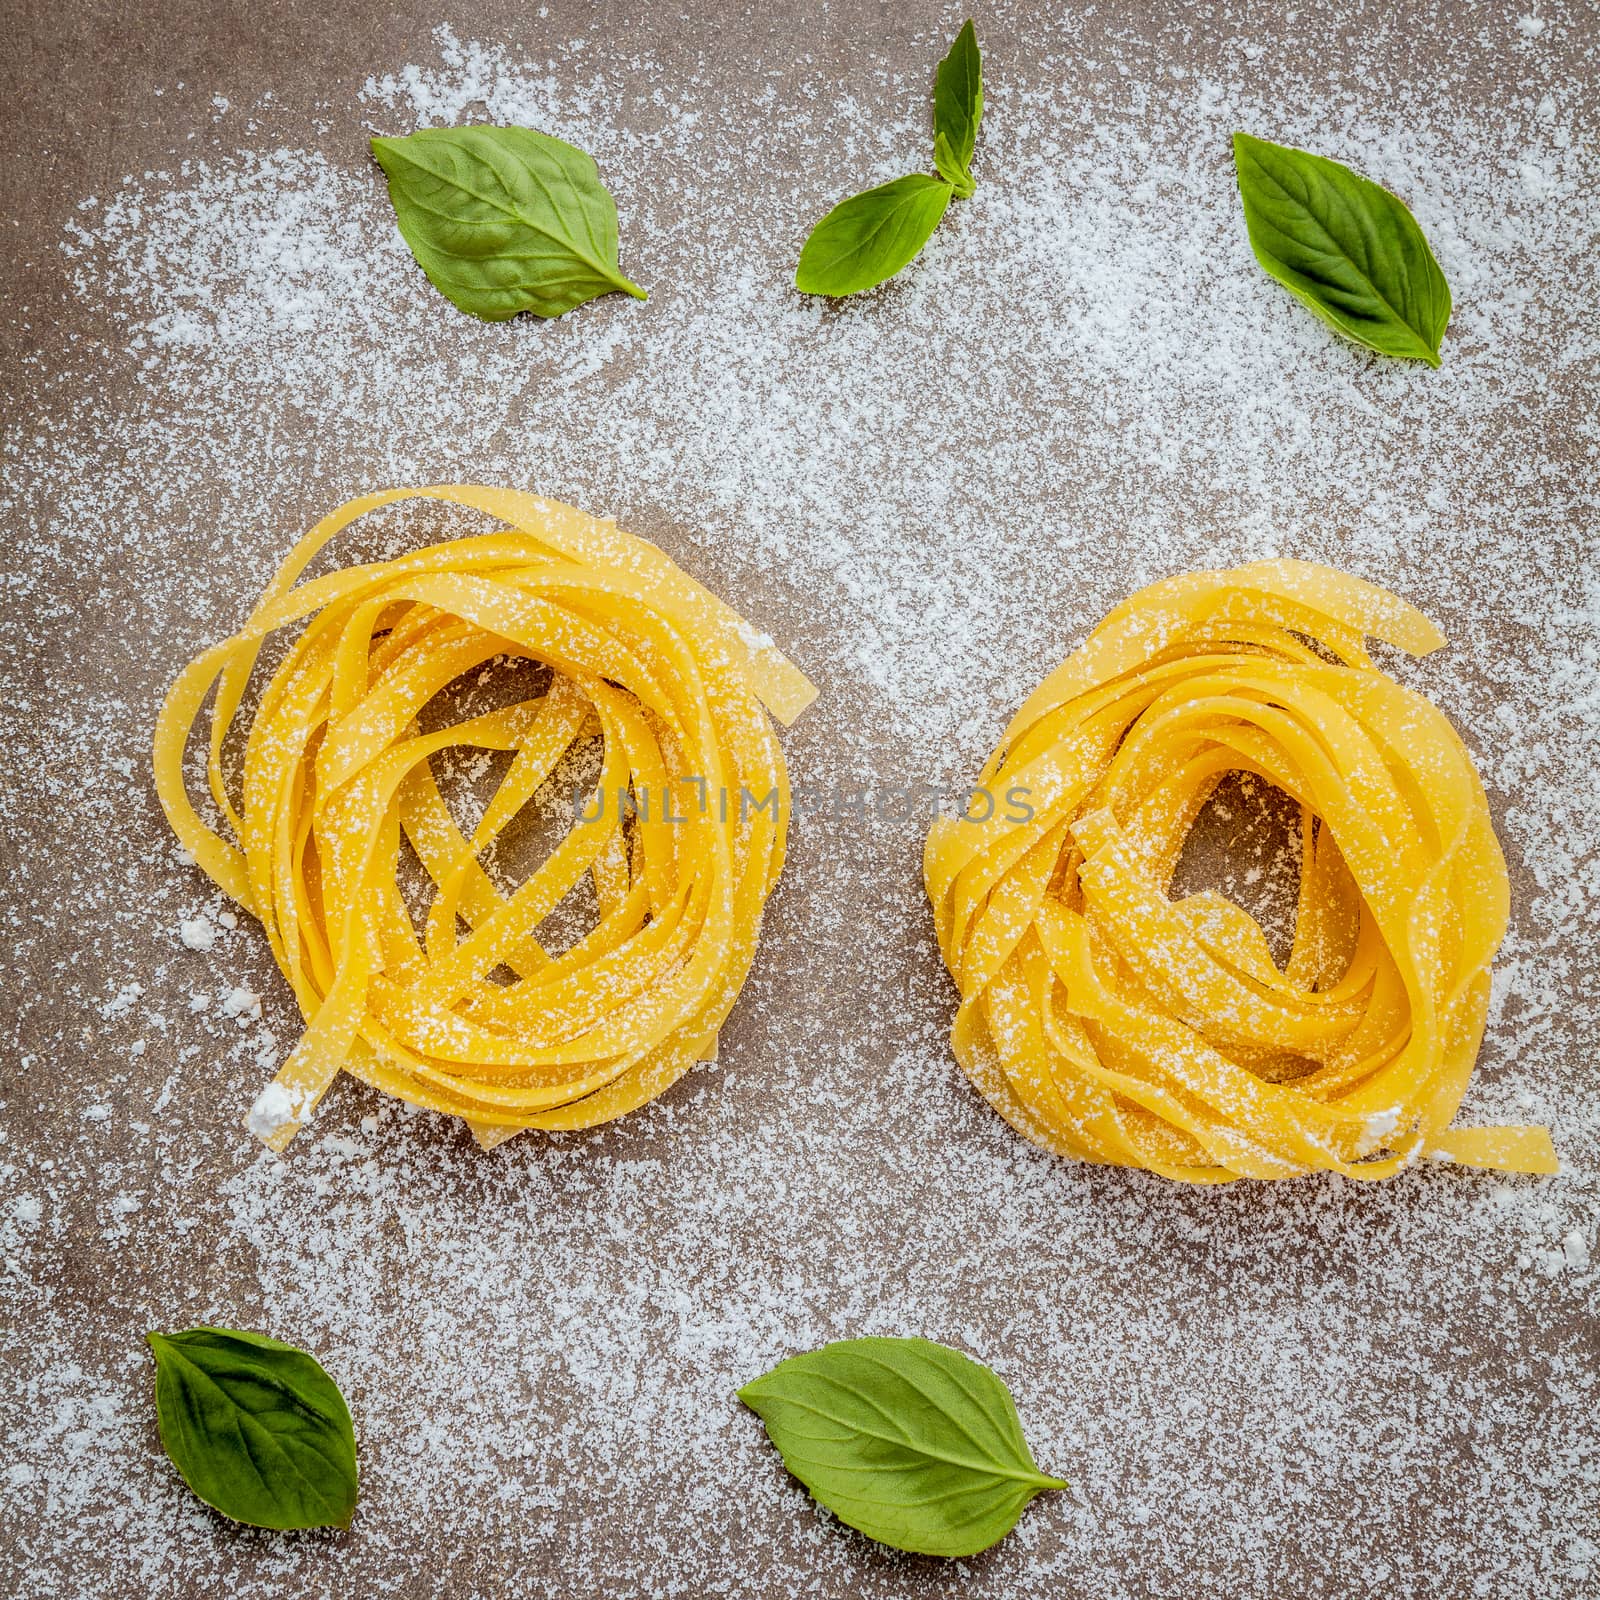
[155,486,816,1149]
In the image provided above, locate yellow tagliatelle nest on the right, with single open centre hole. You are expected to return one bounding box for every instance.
[925,562,1555,1182]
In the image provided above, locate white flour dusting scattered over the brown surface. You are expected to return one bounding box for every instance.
[0,9,1600,1600]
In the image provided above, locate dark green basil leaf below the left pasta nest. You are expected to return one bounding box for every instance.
[147,1328,357,1528]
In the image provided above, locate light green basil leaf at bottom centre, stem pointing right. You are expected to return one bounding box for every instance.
[739,1339,1066,1555]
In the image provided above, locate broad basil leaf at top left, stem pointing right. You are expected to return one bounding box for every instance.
[371,128,645,322]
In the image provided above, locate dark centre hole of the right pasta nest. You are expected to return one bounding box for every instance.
[1171,773,1301,968]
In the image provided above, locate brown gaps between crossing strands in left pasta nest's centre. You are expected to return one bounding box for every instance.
[400,656,611,984]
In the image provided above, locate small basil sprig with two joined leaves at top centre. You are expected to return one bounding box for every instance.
[795,18,984,294]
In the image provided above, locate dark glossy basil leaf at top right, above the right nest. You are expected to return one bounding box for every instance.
[1234,133,1450,366]
